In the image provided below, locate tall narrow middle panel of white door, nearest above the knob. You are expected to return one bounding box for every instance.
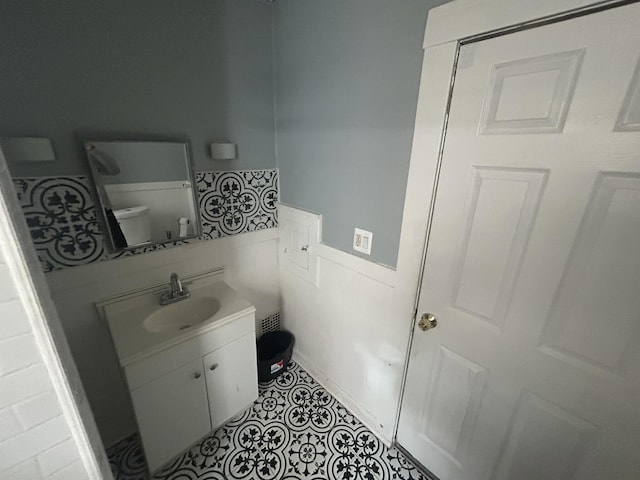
[453,167,547,328]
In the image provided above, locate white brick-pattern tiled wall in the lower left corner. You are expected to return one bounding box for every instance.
[0,260,88,480]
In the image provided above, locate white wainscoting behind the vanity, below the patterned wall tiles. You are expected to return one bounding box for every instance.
[46,229,280,446]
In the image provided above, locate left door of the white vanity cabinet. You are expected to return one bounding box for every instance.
[131,358,211,472]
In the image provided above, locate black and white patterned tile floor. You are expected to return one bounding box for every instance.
[107,363,427,480]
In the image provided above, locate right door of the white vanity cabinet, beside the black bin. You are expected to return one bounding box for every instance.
[204,333,258,429]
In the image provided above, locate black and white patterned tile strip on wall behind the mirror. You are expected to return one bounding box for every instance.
[13,169,278,272]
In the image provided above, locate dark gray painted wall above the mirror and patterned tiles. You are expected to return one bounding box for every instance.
[0,0,275,176]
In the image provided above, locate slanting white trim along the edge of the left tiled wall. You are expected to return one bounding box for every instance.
[0,152,113,480]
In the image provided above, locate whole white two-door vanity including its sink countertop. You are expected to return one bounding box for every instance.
[96,269,258,472]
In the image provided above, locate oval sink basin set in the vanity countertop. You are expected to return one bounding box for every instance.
[142,297,220,333]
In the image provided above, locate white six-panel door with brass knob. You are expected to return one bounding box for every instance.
[398,4,640,480]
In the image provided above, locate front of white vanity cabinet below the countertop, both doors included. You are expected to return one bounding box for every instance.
[124,313,258,472]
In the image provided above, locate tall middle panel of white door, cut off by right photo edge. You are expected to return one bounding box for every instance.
[540,173,640,374]
